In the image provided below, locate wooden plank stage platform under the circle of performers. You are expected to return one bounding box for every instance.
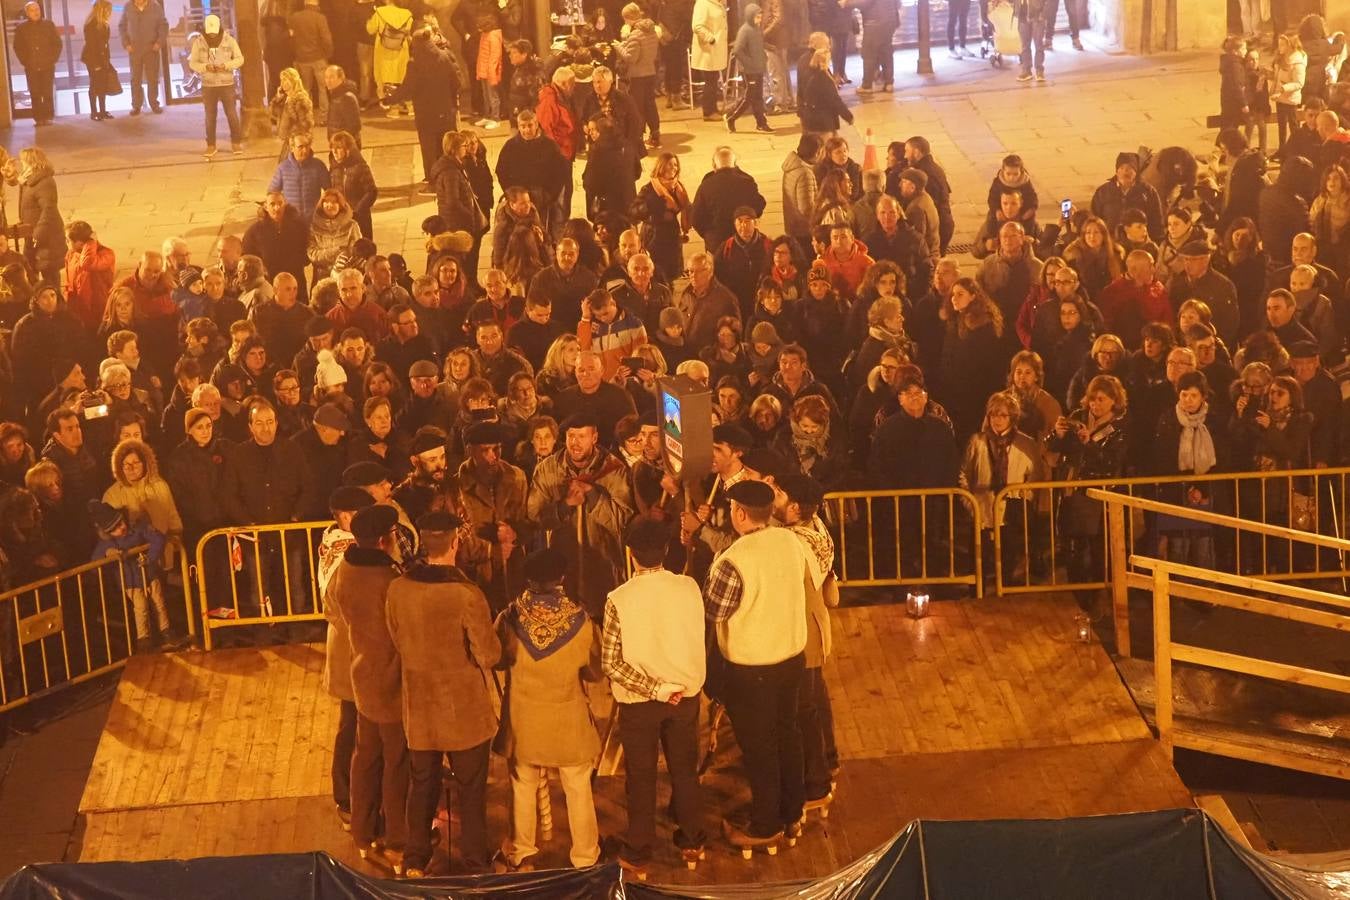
[72,596,1193,884]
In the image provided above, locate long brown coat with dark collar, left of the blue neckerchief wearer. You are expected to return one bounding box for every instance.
[386,564,502,750]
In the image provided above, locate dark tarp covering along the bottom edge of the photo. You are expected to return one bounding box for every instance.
[0,810,1350,900]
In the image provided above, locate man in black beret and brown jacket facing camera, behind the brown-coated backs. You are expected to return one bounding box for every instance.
[448,422,531,610]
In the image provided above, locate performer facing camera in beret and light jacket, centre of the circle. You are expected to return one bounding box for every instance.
[527,413,633,621]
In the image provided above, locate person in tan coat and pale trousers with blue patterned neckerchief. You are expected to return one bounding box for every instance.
[493,548,601,872]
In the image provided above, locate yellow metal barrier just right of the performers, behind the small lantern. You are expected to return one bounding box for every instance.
[824,487,984,596]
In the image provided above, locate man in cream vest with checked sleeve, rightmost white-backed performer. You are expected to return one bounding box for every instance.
[703,479,814,847]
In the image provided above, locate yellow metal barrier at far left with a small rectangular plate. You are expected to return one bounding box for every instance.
[0,545,149,712]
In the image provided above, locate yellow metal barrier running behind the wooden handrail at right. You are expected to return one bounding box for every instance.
[994,468,1350,595]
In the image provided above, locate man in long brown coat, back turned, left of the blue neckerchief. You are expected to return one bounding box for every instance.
[386,513,502,878]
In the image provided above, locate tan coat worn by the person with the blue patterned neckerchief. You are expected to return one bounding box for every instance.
[497,607,601,766]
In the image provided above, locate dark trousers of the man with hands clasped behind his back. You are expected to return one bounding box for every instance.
[617,696,706,862]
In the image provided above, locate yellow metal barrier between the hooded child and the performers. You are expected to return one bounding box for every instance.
[196,521,332,650]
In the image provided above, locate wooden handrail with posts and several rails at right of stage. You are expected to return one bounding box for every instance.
[1091,490,1350,779]
